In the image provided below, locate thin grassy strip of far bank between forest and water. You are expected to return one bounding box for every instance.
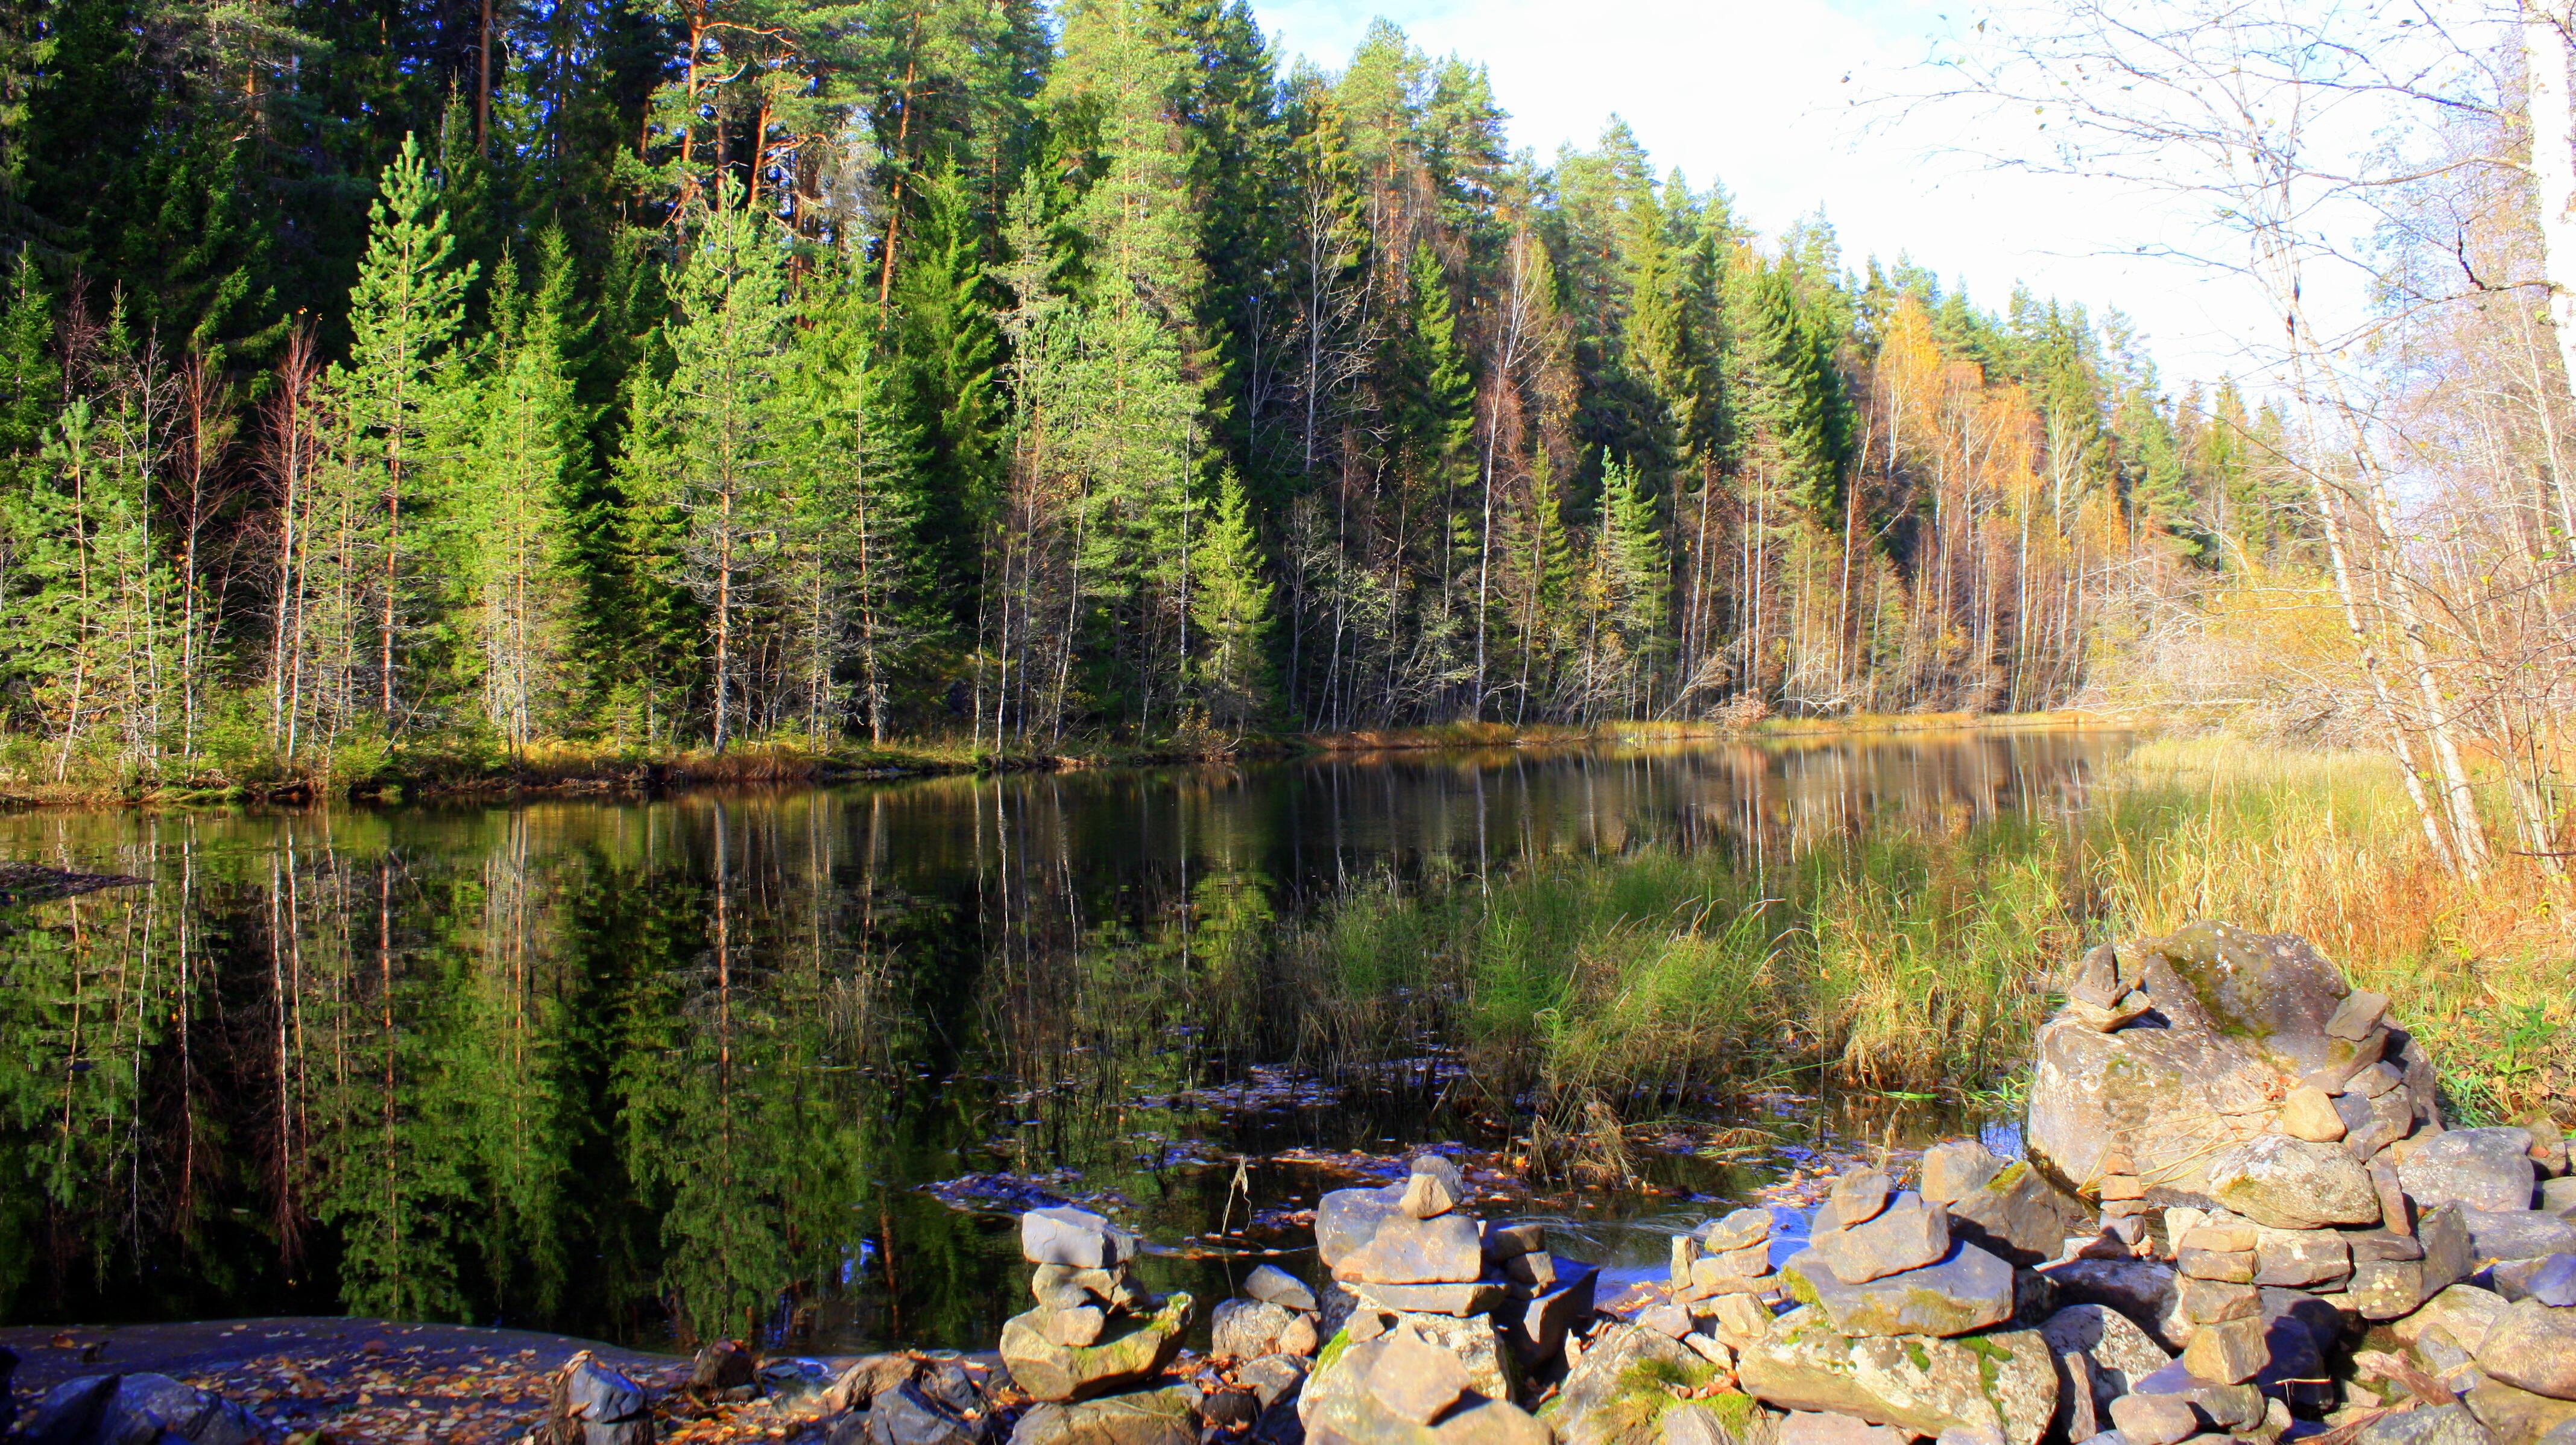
[0,711,2151,811]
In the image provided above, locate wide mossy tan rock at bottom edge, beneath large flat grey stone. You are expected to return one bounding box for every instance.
[1736,1306,2058,1445]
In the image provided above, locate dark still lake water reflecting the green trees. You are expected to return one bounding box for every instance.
[0,734,2125,1350]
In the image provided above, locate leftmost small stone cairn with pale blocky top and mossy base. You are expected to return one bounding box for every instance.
[1002,1208,1201,1445]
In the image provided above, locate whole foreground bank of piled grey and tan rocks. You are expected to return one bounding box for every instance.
[0,925,2576,1445]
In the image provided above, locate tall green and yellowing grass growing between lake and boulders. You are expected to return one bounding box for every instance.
[1283,742,2576,1115]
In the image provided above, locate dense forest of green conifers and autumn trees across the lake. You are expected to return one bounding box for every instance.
[0,0,2300,778]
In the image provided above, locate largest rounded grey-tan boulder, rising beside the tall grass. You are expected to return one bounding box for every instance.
[2027,922,2432,1206]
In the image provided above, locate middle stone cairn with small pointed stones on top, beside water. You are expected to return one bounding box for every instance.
[1298,1154,1556,1445]
